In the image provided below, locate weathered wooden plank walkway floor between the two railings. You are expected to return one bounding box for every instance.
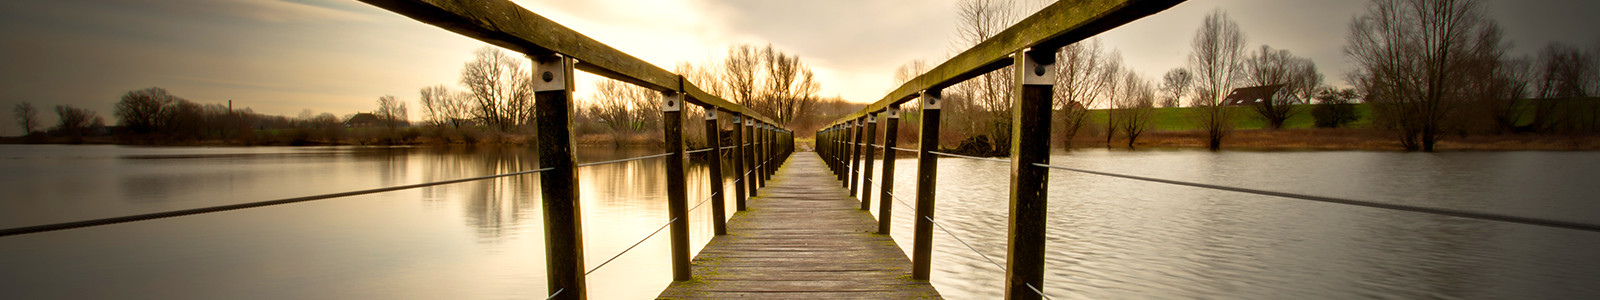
[661,152,939,298]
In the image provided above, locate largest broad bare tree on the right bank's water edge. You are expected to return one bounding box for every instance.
[1344,0,1506,152]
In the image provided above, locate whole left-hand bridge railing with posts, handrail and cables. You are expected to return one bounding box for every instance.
[0,0,794,298]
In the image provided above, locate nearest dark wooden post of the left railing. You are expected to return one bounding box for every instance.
[533,56,589,298]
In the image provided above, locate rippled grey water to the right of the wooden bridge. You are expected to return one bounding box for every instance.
[870,150,1600,298]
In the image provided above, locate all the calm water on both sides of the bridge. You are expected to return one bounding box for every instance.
[0,145,1600,298]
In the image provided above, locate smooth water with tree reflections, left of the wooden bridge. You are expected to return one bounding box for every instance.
[0,145,733,298]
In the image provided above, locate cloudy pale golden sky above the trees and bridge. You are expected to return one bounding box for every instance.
[0,0,1600,136]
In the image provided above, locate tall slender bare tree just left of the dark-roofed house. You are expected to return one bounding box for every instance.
[1189,10,1245,150]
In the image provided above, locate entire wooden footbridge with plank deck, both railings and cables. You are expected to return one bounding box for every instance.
[0,0,1600,298]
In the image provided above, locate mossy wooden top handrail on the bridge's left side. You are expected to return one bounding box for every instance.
[362,0,778,124]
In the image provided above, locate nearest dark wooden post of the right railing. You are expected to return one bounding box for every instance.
[1005,51,1056,300]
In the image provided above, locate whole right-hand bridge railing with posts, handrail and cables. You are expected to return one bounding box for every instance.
[816,0,1600,298]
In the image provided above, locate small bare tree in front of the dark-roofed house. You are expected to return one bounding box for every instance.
[1245,45,1322,129]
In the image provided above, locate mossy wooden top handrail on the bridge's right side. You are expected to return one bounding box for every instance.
[824,0,1184,128]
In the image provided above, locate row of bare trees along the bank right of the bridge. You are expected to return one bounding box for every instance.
[896,0,1600,155]
